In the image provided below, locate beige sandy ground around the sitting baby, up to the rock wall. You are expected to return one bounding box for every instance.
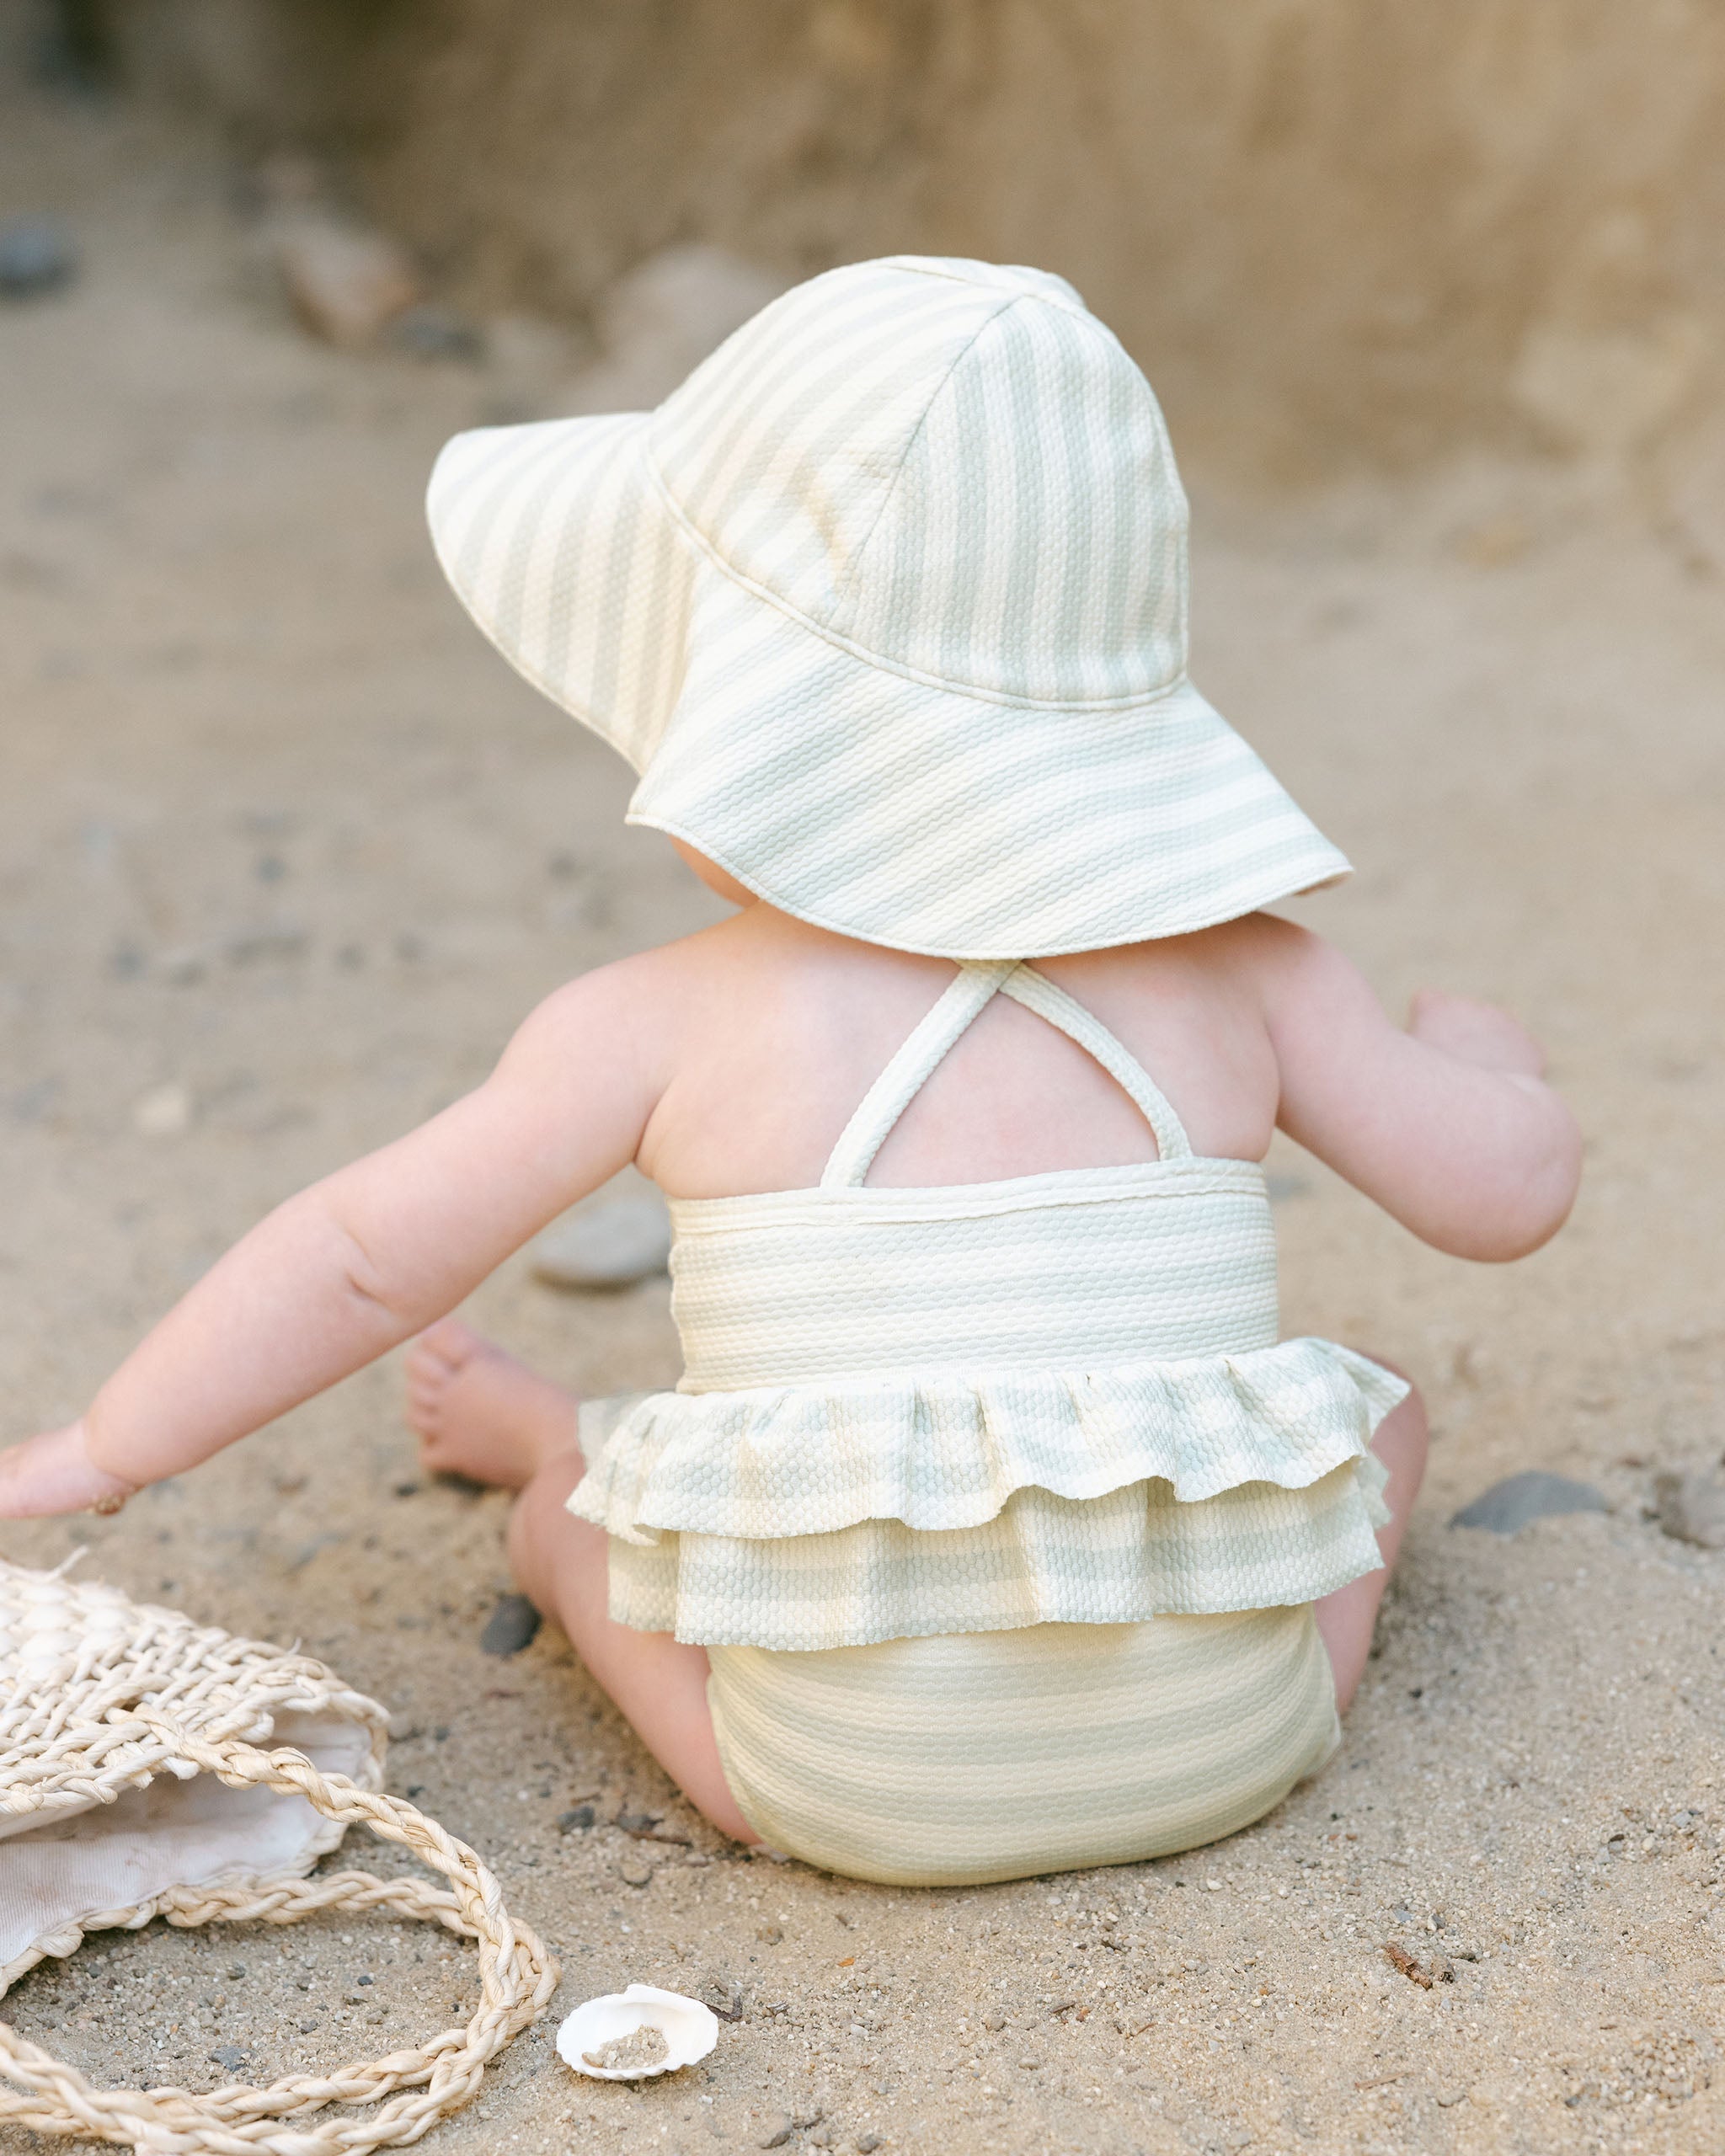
[0,79,1725,2156]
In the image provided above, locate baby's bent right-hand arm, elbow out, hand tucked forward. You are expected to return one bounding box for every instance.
[1252,919,1580,1259]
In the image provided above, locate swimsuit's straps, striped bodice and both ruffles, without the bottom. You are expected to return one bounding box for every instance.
[569,963,1406,1654]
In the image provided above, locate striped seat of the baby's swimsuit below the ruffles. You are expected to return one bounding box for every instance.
[708,1602,1341,1886]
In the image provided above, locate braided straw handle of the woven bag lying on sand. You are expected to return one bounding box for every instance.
[0,1708,558,2156]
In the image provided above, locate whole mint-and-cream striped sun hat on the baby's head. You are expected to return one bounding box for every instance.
[429,254,1348,959]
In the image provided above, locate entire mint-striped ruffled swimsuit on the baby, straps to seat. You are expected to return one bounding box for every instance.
[569,962,1406,1884]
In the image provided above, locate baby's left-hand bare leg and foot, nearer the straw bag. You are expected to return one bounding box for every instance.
[408,1320,759,1844]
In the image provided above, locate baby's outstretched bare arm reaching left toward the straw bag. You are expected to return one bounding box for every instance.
[0,953,664,1518]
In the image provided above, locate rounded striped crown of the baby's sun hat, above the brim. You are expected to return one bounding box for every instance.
[651,257,1186,705]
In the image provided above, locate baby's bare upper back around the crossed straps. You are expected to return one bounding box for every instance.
[638,905,1279,1198]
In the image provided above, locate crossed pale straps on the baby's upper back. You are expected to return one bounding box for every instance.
[821,959,1193,1190]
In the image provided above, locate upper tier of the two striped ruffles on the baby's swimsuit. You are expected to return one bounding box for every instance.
[569,1339,1408,1546]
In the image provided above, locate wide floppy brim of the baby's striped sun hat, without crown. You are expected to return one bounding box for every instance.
[429,414,1350,959]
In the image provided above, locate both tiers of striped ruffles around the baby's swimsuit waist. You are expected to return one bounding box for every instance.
[569,1339,1408,1652]
